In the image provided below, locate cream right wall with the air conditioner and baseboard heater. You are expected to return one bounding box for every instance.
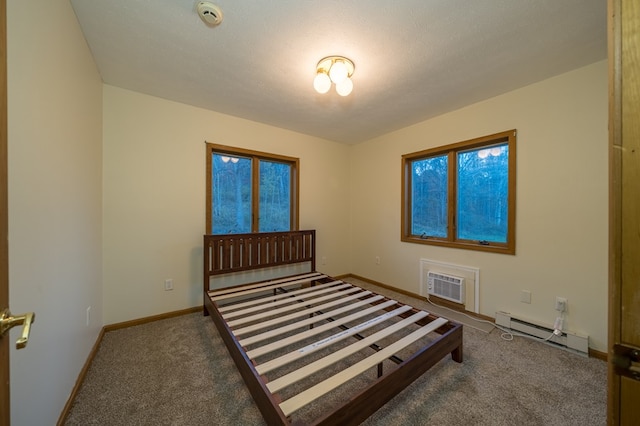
[350,61,608,352]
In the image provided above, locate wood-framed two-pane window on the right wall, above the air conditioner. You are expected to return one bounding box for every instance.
[401,130,516,254]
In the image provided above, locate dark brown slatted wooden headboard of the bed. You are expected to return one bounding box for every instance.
[203,229,316,292]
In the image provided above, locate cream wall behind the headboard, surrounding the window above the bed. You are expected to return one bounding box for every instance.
[103,85,349,324]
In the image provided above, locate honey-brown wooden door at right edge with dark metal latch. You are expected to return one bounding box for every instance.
[608,0,640,425]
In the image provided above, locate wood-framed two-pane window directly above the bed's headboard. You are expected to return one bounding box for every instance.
[207,143,299,234]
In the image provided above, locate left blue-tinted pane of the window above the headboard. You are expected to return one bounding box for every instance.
[211,153,251,234]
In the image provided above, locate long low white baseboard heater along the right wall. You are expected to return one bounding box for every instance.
[496,311,589,356]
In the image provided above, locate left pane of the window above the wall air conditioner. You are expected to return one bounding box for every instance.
[411,155,448,238]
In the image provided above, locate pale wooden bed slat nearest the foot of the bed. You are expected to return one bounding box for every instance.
[278,318,448,416]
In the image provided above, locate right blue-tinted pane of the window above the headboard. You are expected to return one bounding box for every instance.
[260,160,291,232]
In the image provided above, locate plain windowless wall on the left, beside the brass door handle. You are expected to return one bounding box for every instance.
[7,0,102,426]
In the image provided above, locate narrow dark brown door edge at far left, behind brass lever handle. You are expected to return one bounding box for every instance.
[0,0,10,426]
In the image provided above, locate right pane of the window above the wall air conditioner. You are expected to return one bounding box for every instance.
[457,144,509,243]
